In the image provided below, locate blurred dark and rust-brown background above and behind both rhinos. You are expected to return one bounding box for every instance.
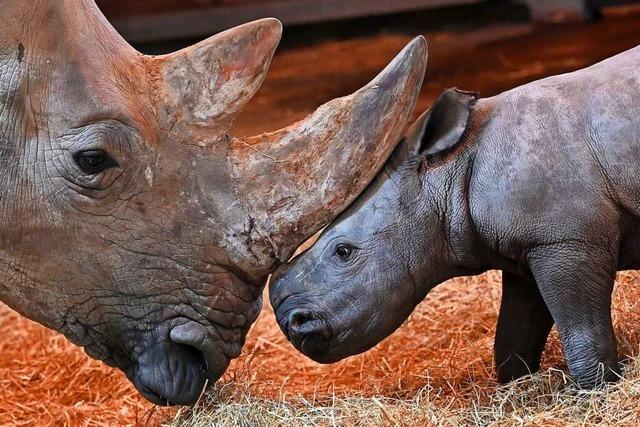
[98,0,640,134]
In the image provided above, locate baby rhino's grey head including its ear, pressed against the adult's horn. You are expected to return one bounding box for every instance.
[270,90,476,363]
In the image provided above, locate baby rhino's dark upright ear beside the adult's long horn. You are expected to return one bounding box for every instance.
[399,88,478,158]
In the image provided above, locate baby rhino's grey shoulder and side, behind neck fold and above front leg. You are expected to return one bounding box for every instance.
[468,49,640,260]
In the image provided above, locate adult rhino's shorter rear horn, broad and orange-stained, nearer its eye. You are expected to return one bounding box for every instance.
[146,18,282,147]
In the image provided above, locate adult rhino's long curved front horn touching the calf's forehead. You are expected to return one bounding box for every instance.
[230,37,427,262]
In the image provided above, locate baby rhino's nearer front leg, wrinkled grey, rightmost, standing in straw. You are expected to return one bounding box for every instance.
[529,242,620,388]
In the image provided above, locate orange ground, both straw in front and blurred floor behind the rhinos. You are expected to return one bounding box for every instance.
[0,5,640,425]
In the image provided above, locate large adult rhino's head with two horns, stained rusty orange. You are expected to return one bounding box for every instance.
[0,0,426,404]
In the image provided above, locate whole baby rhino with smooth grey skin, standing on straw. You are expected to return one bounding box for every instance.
[270,47,640,387]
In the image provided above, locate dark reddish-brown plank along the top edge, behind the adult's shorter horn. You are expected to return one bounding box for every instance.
[103,0,484,43]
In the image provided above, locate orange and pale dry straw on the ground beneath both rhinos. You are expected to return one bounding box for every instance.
[0,272,640,426]
